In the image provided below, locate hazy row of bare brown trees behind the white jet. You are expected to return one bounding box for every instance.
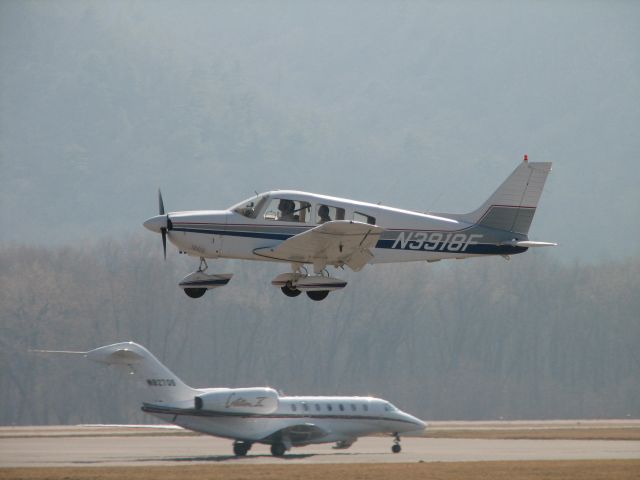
[0,237,640,424]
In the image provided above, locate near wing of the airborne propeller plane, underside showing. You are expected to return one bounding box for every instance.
[254,220,384,272]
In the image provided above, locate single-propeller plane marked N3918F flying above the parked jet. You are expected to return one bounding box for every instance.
[144,155,556,301]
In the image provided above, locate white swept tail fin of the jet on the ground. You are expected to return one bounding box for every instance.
[85,342,199,403]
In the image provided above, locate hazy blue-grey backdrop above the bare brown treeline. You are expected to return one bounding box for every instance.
[0,0,640,261]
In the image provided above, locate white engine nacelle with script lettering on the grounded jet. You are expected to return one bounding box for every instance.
[195,387,278,414]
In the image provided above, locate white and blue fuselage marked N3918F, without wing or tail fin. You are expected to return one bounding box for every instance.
[152,190,527,263]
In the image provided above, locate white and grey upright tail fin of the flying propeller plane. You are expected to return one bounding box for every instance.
[458,157,551,235]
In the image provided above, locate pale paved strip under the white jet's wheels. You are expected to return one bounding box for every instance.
[0,424,640,467]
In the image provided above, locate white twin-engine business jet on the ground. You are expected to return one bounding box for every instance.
[32,342,426,457]
